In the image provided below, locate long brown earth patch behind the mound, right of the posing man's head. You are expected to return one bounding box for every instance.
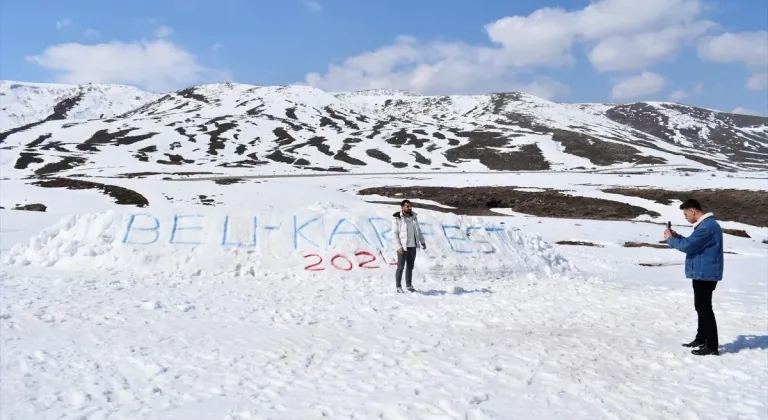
[358,186,659,220]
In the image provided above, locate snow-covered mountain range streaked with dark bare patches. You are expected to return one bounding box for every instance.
[0,82,768,177]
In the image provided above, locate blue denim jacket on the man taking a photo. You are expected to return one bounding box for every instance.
[667,215,724,281]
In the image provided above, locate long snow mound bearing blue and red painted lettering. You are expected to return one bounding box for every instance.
[3,205,575,278]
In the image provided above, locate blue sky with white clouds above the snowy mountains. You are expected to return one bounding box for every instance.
[0,0,768,115]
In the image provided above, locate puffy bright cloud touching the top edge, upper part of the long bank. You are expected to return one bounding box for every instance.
[486,0,714,71]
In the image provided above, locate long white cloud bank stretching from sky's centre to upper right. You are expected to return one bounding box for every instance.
[304,0,715,96]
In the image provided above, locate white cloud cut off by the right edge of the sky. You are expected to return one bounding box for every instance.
[698,31,768,91]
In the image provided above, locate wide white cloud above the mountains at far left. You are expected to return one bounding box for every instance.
[26,39,230,91]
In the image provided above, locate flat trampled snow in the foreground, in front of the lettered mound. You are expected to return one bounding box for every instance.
[0,254,768,420]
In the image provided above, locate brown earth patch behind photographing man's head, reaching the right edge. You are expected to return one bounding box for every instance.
[603,188,768,227]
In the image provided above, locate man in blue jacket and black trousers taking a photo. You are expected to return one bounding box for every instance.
[664,199,724,356]
